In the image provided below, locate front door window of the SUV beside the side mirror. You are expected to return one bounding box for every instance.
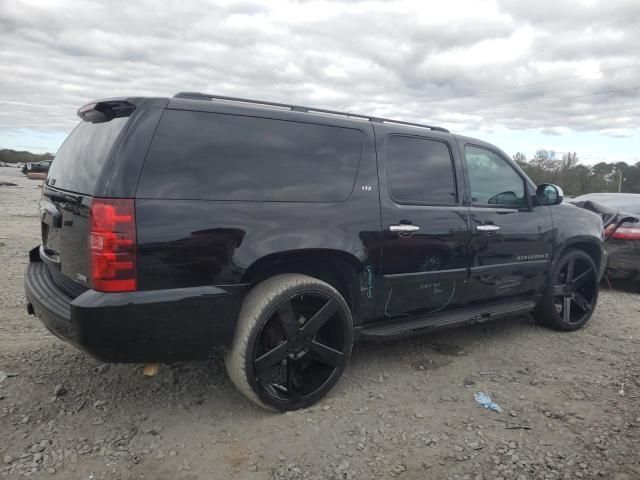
[465,146,527,207]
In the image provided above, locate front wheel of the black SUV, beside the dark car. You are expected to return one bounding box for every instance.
[533,249,599,332]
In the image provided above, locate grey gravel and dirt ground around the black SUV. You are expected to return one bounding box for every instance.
[0,168,640,480]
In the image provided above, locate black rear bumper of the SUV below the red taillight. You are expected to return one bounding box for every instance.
[24,256,248,362]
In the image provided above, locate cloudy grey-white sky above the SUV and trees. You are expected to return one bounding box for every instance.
[0,0,640,164]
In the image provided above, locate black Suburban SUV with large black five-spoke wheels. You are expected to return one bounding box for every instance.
[25,93,606,410]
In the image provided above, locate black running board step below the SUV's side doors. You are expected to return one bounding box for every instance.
[359,300,536,340]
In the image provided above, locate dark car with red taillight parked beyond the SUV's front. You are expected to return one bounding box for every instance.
[571,193,640,280]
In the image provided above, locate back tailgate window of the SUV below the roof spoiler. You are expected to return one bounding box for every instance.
[47,117,128,195]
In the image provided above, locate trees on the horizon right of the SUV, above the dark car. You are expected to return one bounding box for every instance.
[513,150,640,196]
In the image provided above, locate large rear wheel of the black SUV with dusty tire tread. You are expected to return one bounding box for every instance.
[225,274,353,411]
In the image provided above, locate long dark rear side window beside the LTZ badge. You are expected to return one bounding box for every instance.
[137,110,363,202]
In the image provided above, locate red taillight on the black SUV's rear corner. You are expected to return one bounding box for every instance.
[89,198,138,292]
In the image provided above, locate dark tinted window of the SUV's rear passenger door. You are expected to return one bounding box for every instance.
[385,135,457,204]
